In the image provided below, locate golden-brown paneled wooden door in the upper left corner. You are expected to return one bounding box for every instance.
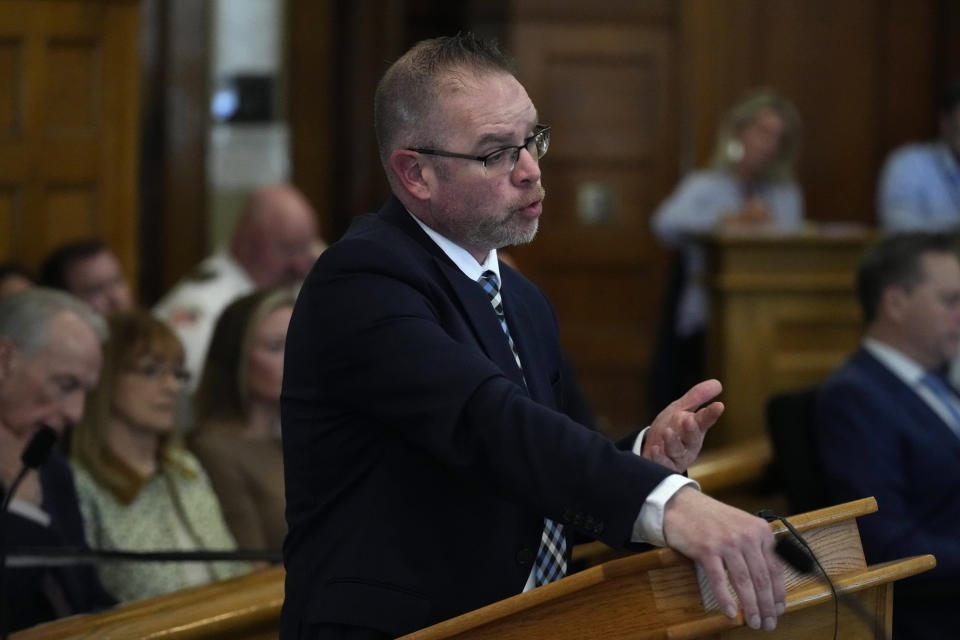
[0,0,139,281]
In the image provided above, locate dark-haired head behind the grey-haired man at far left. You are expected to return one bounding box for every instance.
[40,238,134,316]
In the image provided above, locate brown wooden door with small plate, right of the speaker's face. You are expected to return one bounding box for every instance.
[511,13,677,435]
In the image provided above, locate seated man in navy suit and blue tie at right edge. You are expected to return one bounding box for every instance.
[817,233,960,639]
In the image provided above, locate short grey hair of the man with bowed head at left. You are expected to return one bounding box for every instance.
[0,287,107,358]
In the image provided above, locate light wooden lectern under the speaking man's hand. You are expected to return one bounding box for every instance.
[403,498,936,640]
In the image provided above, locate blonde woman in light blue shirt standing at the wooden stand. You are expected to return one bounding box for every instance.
[650,88,803,407]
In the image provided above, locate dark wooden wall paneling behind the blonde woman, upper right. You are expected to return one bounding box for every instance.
[681,0,936,229]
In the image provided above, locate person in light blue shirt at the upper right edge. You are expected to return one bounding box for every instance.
[877,79,960,231]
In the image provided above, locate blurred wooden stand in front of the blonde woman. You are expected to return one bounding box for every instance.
[702,228,875,448]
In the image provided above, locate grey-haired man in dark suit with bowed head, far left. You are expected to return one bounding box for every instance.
[0,287,114,630]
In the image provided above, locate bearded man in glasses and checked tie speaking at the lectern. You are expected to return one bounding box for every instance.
[281,34,785,638]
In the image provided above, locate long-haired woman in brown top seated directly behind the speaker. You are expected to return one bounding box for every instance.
[189,290,294,549]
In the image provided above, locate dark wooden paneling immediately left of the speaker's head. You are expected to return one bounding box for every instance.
[287,0,405,242]
